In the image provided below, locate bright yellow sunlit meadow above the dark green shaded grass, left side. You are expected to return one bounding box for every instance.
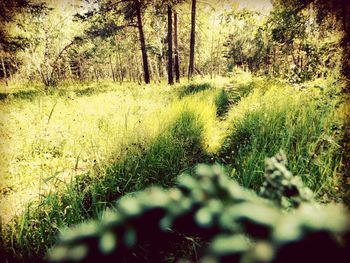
[0,80,175,223]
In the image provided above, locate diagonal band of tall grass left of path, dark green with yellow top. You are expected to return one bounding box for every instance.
[3,82,221,260]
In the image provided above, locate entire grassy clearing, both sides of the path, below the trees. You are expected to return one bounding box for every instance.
[0,75,343,258]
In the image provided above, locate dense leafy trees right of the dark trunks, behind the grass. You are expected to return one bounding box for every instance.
[222,1,342,83]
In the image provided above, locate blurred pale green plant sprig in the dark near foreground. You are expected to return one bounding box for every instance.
[49,155,350,262]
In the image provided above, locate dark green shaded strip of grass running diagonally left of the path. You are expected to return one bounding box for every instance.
[0,111,206,262]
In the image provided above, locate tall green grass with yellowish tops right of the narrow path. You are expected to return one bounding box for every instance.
[218,80,342,198]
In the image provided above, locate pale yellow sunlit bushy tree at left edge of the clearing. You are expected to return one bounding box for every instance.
[21,3,82,86]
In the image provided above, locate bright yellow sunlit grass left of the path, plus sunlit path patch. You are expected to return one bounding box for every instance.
[0,79,224,224]
